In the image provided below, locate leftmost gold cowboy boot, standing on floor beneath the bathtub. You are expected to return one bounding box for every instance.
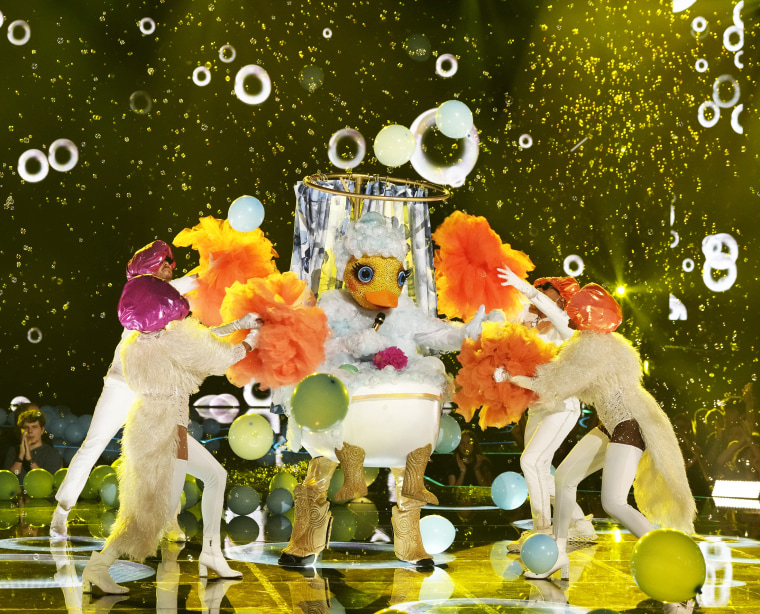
[277,456,338,567]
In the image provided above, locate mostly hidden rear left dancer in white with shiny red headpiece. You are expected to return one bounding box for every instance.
[50,240,253,541]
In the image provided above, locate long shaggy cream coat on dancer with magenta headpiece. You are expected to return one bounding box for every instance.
[106,318,245,561]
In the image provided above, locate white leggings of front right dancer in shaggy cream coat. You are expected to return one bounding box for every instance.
[554,428,654,538]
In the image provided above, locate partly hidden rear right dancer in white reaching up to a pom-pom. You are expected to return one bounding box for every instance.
[497,268,596,552]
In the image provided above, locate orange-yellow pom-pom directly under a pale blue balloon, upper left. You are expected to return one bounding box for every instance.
[173,216,277,326]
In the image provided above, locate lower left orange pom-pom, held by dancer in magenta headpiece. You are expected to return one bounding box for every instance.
[221,272,329,388]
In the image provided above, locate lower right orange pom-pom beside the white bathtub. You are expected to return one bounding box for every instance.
[453,322,557,428]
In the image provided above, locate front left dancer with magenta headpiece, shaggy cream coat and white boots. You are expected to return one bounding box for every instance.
[82,275,258,593]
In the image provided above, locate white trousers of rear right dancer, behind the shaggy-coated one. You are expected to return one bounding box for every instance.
[520,399,583,529]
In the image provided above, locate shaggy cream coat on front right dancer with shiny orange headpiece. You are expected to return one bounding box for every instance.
[531,331,696,533]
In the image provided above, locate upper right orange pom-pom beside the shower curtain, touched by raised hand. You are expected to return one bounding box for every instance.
[433,211,535,321]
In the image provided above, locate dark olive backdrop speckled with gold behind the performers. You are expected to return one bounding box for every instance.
[0,0,760,428]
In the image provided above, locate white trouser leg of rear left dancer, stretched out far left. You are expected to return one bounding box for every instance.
[55,377,135,509]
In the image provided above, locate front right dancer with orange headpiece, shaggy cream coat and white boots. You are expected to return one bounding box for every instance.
[494,284,696,579]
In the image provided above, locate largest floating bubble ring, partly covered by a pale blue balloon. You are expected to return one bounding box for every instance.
[411,109,480,187]
